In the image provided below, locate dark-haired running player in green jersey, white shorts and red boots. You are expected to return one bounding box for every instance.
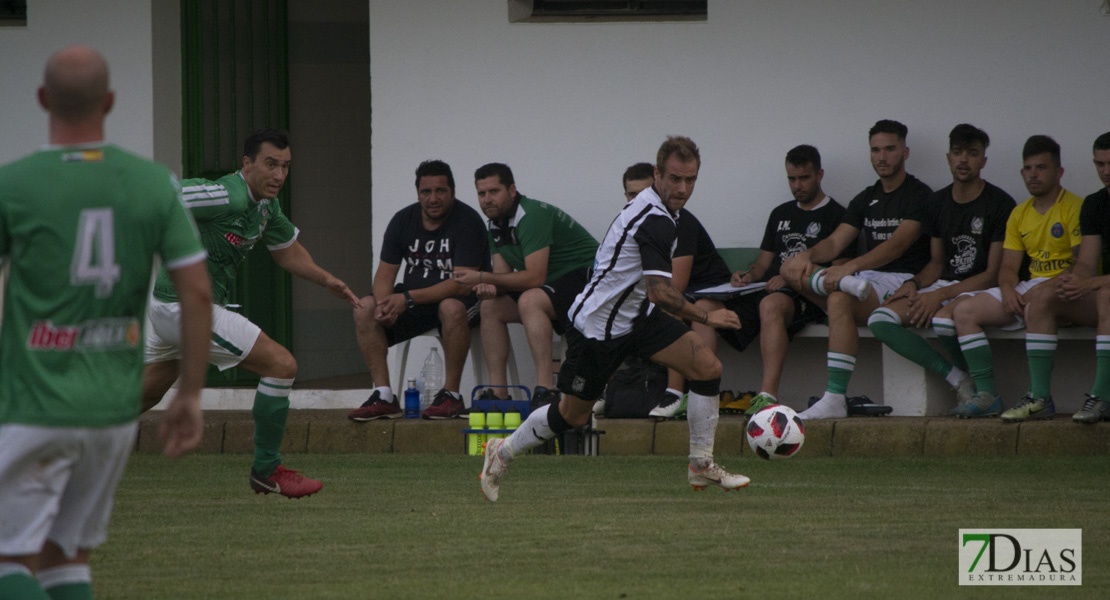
[143,129,361,498]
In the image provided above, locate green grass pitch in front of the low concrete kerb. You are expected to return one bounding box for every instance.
[93,454,1110,600]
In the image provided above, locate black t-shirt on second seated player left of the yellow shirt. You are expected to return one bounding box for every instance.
[841,174,932,273]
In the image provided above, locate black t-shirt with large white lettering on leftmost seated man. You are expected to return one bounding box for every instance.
[381,200,490,289]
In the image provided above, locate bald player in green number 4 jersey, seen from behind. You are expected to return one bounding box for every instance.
[0,45,212,600]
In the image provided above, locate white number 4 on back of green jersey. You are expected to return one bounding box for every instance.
[70,209,120,298]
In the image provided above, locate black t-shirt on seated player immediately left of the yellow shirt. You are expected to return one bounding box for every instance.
[915,182,1016,282]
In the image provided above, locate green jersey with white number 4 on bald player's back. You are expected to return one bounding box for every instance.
[0,143,204,427]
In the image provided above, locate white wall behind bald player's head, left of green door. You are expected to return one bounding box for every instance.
[0,0,156,164]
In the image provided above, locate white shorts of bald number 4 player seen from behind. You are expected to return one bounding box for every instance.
[0,423,139,559]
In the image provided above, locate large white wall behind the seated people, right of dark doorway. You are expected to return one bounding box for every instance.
[370,0,1110,250]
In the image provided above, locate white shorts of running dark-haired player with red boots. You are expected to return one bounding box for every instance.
[143,298,262,370]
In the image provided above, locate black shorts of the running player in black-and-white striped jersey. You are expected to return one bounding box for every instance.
[556,307,690,401]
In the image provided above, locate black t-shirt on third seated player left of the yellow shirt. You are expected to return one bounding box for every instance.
[759,197,852,281]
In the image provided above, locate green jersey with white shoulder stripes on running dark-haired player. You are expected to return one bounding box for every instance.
[154,171,300,305]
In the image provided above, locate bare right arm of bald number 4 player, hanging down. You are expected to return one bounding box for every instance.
[159,262,212,458]
